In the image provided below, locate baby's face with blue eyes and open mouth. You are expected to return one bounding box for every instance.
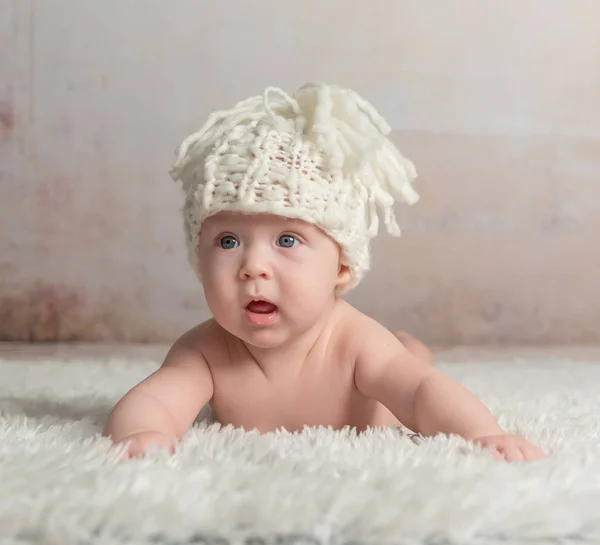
[198,212,348,348]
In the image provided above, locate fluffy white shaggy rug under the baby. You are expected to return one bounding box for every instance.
[0,344,600,545]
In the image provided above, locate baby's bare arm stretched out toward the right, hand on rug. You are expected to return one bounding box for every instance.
[355,319,541,459]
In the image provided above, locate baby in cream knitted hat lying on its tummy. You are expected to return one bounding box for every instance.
[104,84,543,460]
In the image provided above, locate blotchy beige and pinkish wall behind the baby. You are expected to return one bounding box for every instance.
[0,0,600,344]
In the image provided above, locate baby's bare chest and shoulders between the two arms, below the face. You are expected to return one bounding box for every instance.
[188,300,400,432]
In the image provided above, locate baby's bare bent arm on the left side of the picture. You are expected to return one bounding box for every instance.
[103,335,213,455]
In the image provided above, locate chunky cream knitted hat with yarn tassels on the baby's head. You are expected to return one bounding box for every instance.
[171,83,419,288]
